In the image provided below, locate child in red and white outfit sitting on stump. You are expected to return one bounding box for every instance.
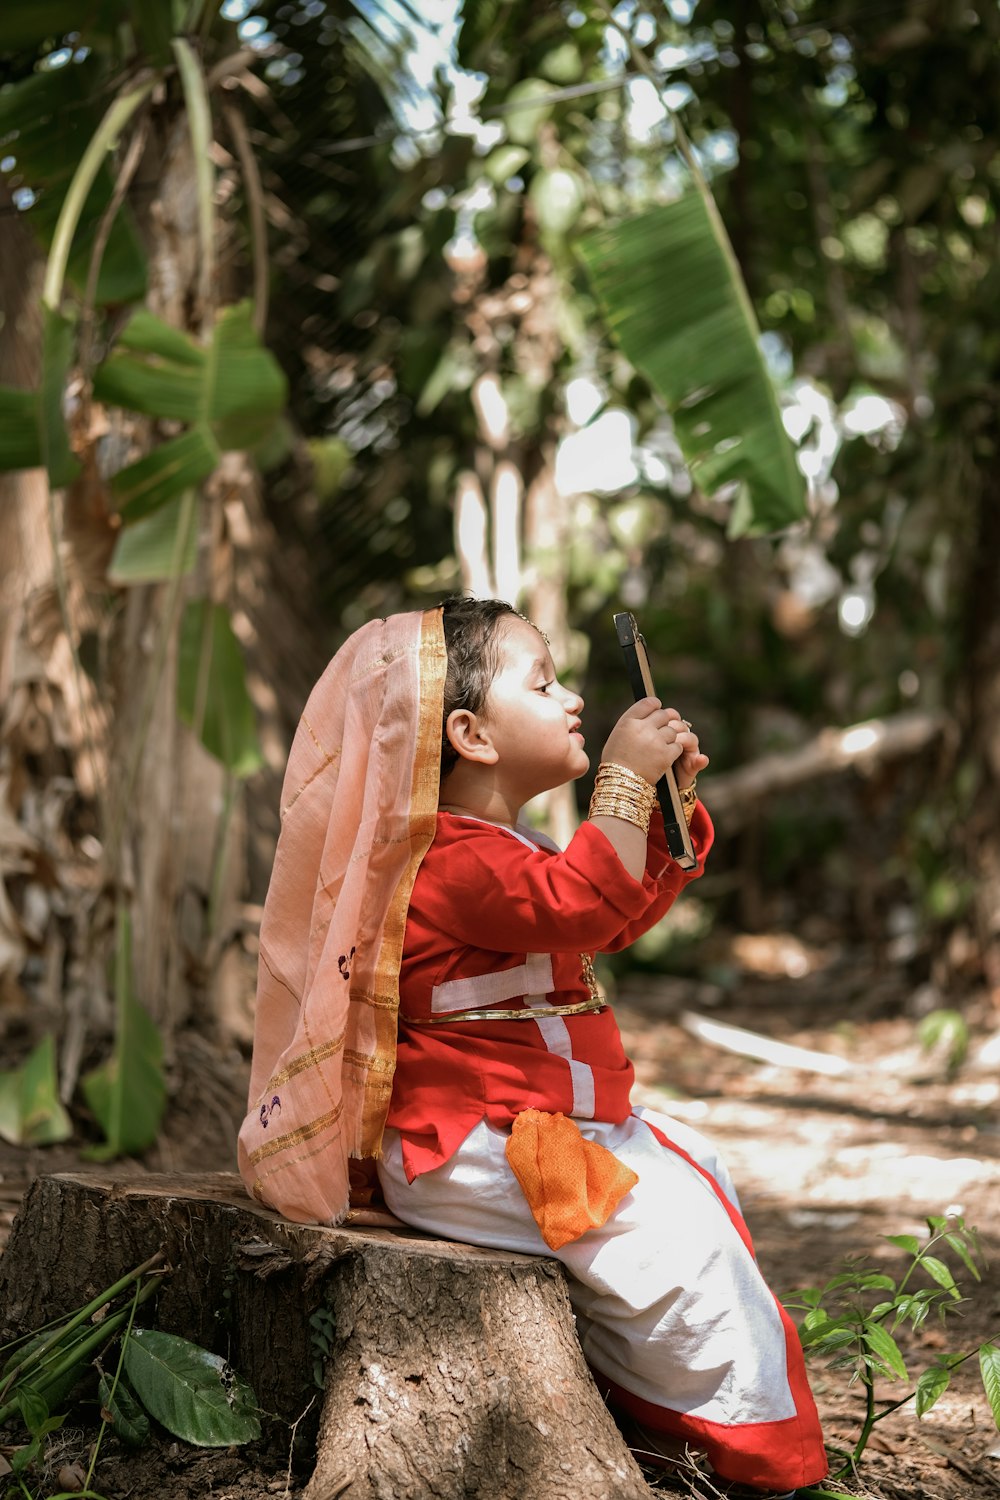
[240,599,826,1491]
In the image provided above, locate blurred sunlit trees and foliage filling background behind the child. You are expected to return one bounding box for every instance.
[0,0,1000,1152]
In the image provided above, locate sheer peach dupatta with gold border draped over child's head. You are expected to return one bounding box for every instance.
[238,609,447,1224]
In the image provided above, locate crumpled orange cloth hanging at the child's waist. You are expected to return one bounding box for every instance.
[507,1110,639,1250]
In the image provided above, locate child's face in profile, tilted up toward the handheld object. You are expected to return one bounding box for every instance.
[483,618,591,803]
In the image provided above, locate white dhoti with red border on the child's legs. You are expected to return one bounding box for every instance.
[379,1109,826,1490]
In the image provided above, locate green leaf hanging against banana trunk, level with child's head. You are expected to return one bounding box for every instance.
[177,600,264,777]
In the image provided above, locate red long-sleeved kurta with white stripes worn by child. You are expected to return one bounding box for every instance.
[387,803,712,1182]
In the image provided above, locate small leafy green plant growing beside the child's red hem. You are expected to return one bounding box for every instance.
[786,1215,1000,1479]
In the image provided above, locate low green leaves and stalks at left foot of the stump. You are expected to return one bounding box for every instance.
[0,1256,261,1500]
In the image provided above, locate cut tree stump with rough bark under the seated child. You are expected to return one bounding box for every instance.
[0,1173,651,1500]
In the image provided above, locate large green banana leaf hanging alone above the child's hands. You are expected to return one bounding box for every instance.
[577,192,805,531]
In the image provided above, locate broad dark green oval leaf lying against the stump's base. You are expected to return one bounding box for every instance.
[124,1328,261,1448]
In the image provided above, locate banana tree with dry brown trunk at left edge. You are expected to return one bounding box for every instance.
[0,0,286,1154]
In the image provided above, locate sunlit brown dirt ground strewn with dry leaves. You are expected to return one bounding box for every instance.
[0,936,1000,1500]
